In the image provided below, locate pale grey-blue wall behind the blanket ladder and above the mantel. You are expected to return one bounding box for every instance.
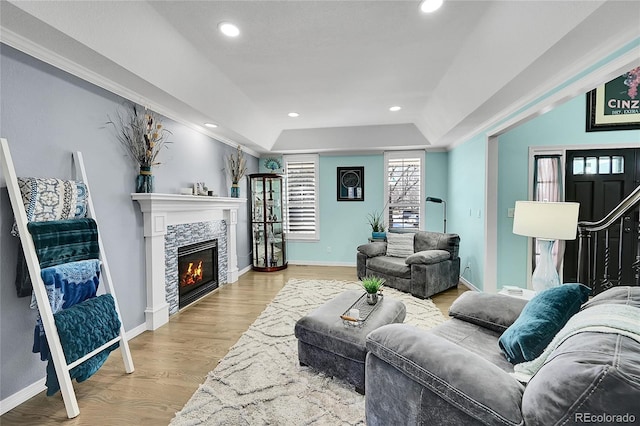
[0,44,258,399]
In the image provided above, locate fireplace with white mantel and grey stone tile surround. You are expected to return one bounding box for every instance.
[131,193,246,330]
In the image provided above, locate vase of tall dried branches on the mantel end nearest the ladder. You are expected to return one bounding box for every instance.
[107,104,171,192]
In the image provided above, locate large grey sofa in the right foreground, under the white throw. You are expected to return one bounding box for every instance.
[365,287,640,426]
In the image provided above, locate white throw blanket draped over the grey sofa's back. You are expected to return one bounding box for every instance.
[512,304,640,383]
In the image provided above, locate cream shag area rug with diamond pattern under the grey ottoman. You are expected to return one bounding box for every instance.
[170,279,445,426]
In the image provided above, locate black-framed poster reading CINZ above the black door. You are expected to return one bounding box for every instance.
[586,67,640,132]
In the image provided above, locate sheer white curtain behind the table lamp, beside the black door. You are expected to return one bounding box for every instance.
[533,155,565,272]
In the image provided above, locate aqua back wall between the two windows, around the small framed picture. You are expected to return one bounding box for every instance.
[287,155,384,264]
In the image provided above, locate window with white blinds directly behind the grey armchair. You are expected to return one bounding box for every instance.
[384,151,424,229]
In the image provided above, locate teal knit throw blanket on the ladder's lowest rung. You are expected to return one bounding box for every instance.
[46,294,120,396]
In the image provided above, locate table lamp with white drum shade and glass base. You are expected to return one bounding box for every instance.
[513,201,580,291]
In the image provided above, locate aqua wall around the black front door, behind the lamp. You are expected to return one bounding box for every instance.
[498,95,640,288]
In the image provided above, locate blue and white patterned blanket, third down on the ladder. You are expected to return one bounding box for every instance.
[31,259,100,361]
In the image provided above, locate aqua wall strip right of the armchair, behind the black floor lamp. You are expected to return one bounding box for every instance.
[447,135,486,290]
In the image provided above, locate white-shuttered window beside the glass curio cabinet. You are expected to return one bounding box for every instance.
[283,155,320,240]
